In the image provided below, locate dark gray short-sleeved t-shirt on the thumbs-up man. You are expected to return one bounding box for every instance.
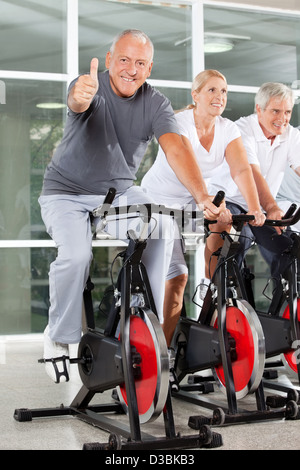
[42,71,180,195]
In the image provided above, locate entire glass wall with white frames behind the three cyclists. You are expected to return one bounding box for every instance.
[0,0,300,335]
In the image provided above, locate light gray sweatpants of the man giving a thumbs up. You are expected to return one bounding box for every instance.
[39,186,174,344]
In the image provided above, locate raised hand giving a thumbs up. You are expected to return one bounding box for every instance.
[68,57,99,113]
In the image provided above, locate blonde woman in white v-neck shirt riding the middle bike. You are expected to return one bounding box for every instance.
[142,70,265,352]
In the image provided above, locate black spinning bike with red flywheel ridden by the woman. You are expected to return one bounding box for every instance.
[173,198,300,428]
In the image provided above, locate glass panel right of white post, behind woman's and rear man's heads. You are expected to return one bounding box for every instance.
[204,5,300,126]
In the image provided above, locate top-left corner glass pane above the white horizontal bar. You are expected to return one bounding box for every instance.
[0,0,67,73]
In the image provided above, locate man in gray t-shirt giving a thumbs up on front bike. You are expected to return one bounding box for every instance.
[39,30,220,382]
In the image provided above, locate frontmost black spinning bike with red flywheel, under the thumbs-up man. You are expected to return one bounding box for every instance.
[14,189,222,450]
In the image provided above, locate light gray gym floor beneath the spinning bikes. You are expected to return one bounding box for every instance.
[0,335,300,452]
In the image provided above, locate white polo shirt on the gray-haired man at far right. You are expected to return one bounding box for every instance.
[209,114,300,210]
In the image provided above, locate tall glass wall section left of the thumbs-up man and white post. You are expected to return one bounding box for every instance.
[0,0,67,334]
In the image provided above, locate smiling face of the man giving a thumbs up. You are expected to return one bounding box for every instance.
[105,34,153,98]
